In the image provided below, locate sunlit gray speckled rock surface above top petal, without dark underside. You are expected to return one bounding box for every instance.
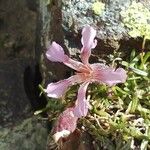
[62,0,131,40]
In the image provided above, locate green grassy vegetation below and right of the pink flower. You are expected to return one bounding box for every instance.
[39,50,150,150]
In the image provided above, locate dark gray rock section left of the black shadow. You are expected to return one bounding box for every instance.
[0,59,33,126]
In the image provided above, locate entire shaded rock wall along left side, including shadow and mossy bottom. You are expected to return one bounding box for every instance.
[0,0,48,150]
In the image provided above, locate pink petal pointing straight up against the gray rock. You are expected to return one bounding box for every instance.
[81,26,97,64]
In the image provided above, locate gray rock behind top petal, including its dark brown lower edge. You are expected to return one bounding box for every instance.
[62,0,149,54]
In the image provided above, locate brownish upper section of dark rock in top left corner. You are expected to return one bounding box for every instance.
[0,0,36,60]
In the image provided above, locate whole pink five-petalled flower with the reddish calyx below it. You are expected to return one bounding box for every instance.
[45,25,127,141]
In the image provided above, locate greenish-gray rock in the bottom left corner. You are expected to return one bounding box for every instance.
[0,116,48,150]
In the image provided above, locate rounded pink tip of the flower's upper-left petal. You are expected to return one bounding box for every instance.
[46,42,69,62]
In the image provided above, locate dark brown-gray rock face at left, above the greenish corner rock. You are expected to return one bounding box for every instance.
[0,0,36,126]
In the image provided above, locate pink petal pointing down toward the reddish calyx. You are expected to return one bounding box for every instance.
[73,82,89,118]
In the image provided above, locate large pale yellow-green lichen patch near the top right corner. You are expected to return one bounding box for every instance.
[120,1,150,39]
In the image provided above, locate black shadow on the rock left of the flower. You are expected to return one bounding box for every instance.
[24,64,47,111]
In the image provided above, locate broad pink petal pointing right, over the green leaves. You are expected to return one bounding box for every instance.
[91,64,127,86]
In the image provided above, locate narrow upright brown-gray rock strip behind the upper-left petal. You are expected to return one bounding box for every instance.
[36,0,70,86]
